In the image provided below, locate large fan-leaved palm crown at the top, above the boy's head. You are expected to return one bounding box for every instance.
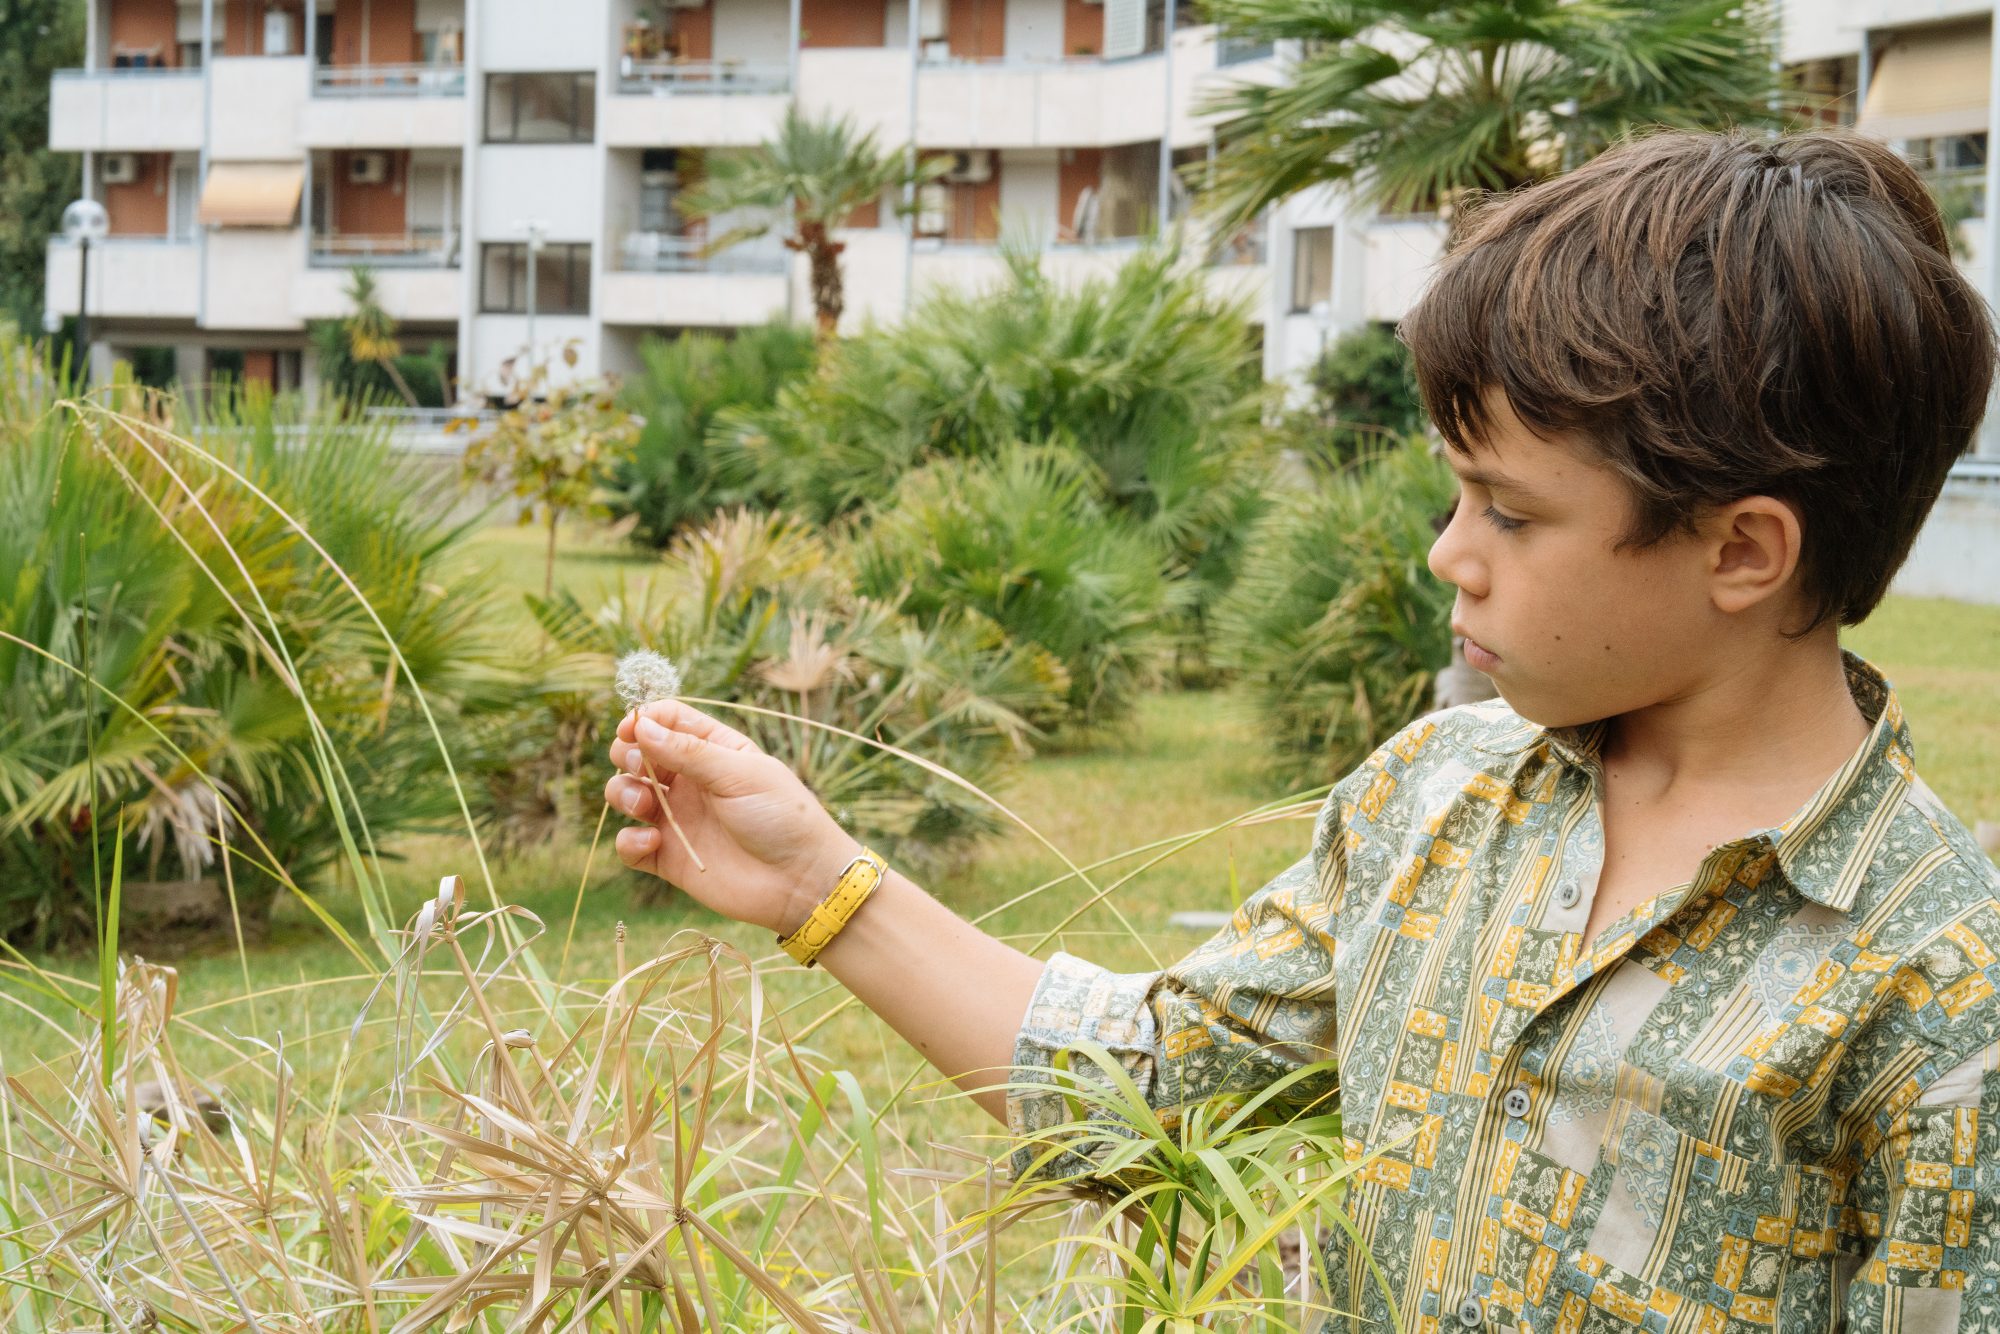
[1202,0,1778,224]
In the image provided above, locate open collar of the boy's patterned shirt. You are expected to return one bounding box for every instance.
[1480,650,1916,912]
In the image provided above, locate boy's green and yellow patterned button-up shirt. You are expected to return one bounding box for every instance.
[1008,654,2000,1334]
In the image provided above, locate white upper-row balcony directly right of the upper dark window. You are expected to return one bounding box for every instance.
[604,56,792,148]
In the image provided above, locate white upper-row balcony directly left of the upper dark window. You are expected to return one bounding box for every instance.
[298,64,466,148]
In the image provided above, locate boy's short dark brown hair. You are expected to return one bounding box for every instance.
[1400,132,1994,628]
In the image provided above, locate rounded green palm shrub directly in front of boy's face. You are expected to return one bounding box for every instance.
[1216,442,1456,784]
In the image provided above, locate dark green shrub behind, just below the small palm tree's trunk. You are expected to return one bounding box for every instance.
[610,324,812,546]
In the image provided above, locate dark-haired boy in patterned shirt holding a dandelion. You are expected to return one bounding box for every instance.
[608,134,2000,1334]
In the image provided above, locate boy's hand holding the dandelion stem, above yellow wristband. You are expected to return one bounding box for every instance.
[604,700,860,936]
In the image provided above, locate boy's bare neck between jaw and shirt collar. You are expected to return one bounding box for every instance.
[1602,626,1870,818]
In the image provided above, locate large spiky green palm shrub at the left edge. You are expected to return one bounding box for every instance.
[0,352,516,940]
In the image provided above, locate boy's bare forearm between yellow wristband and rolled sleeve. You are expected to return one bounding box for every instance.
[800,868,1042,1124]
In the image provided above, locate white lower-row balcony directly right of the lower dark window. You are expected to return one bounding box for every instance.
[600,232,790,328]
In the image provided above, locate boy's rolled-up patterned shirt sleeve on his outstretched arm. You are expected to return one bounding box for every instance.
[1008,788,1346,1178]
